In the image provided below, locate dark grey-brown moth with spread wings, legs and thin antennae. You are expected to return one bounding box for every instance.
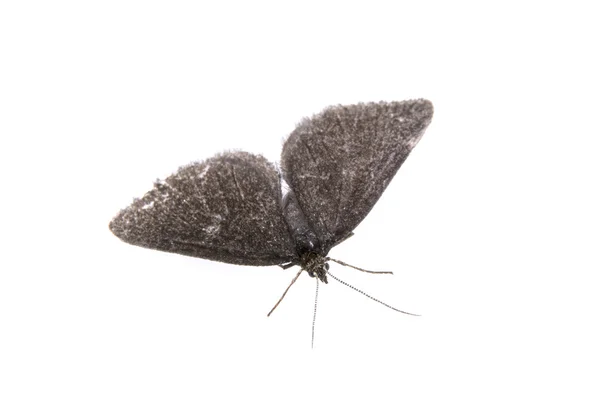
[109,99,433,341]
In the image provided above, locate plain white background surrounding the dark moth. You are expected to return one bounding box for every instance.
[0,0,600,400]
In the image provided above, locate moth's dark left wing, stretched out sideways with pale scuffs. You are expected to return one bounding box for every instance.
[110,152,298,265]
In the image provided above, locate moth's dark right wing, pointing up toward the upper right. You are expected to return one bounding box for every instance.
[281,100,433,252]
